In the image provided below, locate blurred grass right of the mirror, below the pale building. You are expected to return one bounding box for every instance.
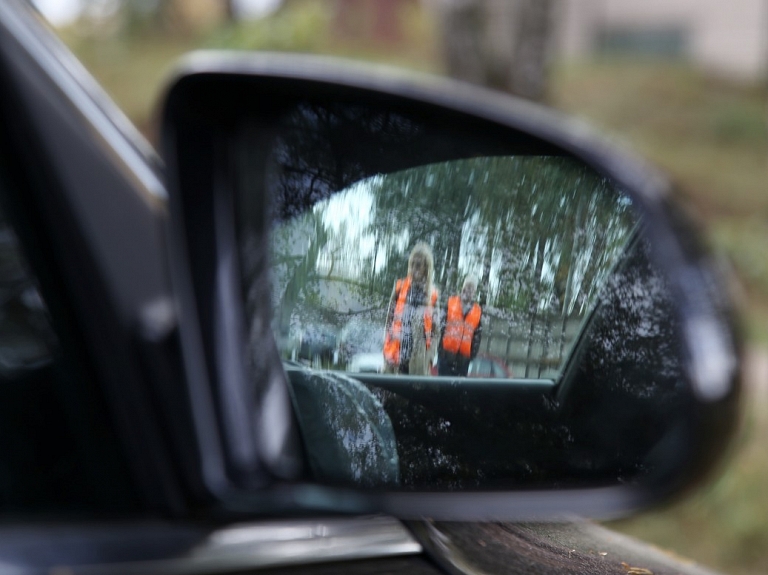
[551,60,768,344]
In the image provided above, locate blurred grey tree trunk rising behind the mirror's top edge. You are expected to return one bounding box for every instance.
[429,0,558,100]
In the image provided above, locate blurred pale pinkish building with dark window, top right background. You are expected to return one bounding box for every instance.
[556,0,768,81]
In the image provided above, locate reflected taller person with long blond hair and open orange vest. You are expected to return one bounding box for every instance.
[384,242,438,375]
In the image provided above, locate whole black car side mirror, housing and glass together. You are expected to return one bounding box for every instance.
[162,53,739,520]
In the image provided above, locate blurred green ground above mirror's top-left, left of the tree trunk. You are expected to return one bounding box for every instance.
[58,0,440,134]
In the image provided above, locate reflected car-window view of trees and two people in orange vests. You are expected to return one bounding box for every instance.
[272,156,636,379]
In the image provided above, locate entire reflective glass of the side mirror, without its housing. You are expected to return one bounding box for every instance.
[234,99,690,490]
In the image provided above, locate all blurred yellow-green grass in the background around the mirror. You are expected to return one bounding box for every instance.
[55,1,768,575]
